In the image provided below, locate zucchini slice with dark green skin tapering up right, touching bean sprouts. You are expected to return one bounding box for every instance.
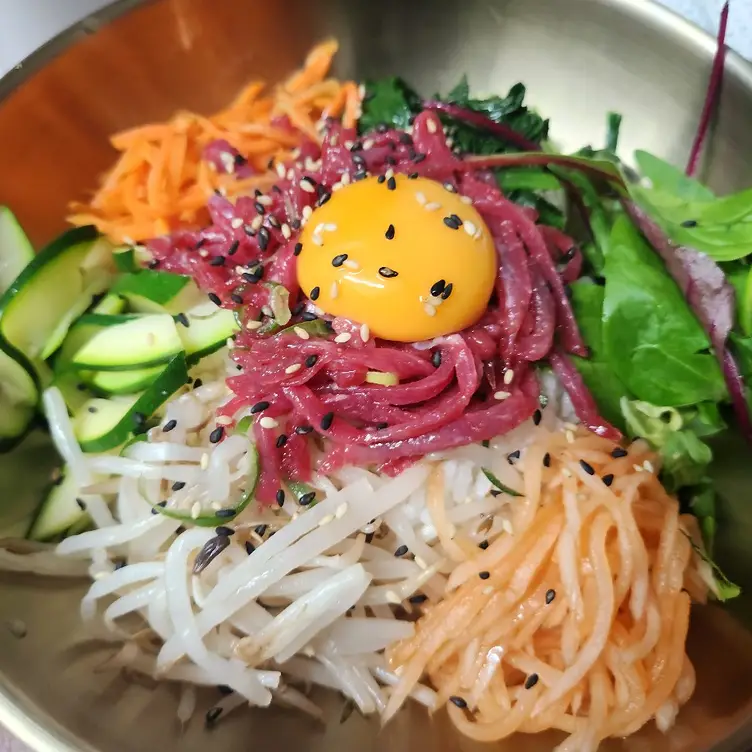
[73,352,188,452]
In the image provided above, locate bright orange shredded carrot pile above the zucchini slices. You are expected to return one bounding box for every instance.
[68,40,361,243]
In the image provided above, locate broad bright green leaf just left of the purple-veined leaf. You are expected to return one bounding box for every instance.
[602,217,726,407]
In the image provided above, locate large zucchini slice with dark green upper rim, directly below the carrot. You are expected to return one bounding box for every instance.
[0,227,114,363]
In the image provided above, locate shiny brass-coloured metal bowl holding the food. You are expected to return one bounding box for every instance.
[0,0,752,752]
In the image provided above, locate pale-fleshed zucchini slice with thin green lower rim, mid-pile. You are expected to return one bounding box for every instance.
[70,313,183,371]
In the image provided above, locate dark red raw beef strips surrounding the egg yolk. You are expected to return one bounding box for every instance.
[149,110,618,494]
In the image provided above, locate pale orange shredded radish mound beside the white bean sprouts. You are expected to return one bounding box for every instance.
[384,431,707,752]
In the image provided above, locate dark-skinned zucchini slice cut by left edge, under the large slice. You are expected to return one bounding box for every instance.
[0,340,39,452]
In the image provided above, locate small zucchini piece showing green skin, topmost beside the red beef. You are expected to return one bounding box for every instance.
[111,269,202,314]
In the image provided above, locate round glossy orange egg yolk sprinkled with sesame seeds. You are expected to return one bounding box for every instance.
[297,175,497,342]
